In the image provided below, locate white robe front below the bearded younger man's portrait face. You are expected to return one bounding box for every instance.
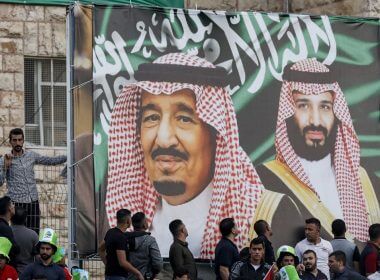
[299,154,343,219]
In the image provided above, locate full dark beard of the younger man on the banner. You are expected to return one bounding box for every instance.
[286,117,338,161]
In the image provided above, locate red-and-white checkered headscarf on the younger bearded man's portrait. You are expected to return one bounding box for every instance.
[275,59,369,241]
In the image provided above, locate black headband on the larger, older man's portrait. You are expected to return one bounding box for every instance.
[135,63,229,87]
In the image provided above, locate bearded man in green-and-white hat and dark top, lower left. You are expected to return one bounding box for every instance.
[20,228,65,280]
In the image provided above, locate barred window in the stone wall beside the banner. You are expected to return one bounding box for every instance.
[24,58,66,147]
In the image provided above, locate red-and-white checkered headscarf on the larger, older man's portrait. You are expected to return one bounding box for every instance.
[106,53,263,259]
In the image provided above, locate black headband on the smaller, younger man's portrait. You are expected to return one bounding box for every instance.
[282,64,336,84]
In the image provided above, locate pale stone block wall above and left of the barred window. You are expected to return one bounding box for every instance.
[0,4,66,146]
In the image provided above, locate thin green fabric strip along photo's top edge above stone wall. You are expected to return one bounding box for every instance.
[0,0,185,8]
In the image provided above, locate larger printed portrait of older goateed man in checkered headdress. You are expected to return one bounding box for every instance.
[105,53,302,259]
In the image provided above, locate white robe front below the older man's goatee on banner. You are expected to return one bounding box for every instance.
[150,184,212,258]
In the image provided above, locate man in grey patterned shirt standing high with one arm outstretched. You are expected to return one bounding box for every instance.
[0,128,66,233]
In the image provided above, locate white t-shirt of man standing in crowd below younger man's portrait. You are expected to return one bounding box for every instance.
[295,238,333,279]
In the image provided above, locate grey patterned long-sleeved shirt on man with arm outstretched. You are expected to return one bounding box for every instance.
[0,151,66,203]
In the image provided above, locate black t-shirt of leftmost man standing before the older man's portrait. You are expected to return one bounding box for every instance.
[104,227,128,277]
